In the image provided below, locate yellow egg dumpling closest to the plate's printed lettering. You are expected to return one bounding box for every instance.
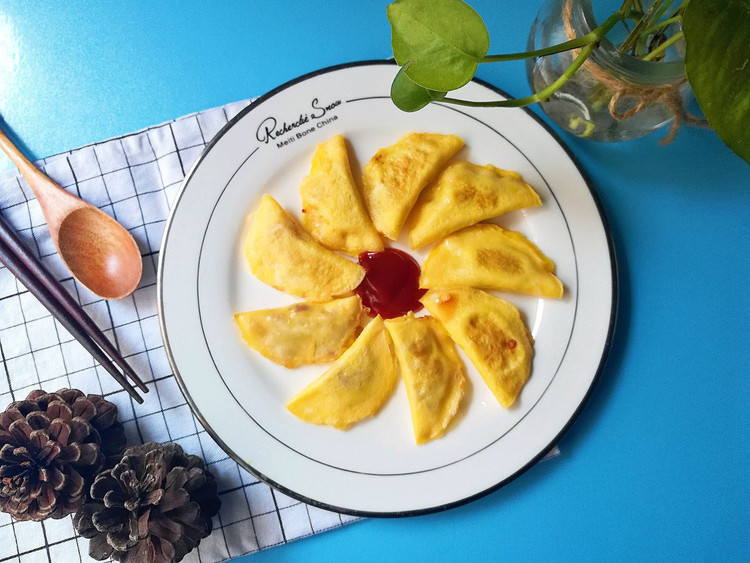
[300,135,383,256]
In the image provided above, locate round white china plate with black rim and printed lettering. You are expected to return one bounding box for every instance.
[158,61,616,516]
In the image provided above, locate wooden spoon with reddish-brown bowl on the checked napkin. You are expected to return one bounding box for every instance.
[0,130,143,299]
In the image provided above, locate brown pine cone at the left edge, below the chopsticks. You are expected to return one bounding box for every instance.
[0,389,125,521]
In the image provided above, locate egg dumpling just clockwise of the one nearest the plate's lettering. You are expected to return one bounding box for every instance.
[362,133,464,240]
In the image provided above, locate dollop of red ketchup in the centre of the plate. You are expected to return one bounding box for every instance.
[354,248,426,319]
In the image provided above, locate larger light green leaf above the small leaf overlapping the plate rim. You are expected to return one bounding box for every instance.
[388,0,490,92]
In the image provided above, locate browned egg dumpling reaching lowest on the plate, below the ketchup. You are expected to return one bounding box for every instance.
[385,313,466,444]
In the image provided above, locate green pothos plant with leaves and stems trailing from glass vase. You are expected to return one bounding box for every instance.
[388,0,750,163]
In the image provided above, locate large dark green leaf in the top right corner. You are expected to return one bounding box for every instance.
[682,0,750,163]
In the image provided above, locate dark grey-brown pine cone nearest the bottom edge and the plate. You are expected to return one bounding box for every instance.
[73,442,220,563]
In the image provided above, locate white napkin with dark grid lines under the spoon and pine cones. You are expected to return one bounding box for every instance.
[0,100,356,563]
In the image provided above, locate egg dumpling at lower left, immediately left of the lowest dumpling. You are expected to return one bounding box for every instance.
[286,317,397,430]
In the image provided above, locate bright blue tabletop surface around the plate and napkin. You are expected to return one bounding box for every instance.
[0,0,750,562]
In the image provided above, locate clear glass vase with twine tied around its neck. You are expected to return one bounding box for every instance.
[527,0,692,141]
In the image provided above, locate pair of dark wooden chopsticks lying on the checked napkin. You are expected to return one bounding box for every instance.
[0,215,148,403]
